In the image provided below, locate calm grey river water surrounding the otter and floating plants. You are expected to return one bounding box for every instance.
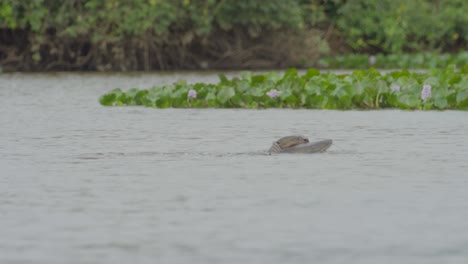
[0,73,468,264]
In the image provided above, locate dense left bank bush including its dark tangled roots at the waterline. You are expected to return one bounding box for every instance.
[0,0,330,70]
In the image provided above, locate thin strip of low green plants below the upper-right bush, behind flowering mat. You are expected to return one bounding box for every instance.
[318,51,468,69]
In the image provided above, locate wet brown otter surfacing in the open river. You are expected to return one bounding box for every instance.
[268,135,333,154]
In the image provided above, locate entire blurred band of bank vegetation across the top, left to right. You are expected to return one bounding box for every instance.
[0,0,468,70]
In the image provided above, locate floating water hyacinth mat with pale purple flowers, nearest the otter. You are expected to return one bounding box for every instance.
[100,68,468,110]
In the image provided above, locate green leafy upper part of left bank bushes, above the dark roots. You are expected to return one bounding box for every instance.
[0,0,323,42]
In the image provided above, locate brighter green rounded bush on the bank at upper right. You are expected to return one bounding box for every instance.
[336,0,468,53]
